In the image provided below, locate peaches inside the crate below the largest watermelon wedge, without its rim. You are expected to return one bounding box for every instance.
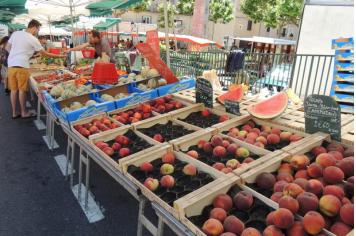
[222,120,303,152]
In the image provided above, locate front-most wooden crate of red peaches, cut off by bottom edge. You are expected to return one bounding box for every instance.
[174,159,322,236]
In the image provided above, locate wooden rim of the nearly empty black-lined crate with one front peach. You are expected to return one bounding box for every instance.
[132,114,203,143]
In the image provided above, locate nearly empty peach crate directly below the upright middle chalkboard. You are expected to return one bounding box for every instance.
[171,103,239,128]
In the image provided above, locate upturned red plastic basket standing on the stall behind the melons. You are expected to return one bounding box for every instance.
[91,63,118,84]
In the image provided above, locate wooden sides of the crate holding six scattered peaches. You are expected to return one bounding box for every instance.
[122,148,225,219]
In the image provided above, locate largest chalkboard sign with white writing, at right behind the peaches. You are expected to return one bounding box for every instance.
[304,94,341,141]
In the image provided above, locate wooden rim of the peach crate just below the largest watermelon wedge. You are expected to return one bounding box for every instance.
[212,115,310,152]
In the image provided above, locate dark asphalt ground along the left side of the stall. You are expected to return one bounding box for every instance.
[0,84,173,236]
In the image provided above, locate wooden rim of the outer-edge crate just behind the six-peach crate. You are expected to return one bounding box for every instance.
[89,126,163,172]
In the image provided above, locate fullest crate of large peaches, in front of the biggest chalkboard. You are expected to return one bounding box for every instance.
[240,134,354,235]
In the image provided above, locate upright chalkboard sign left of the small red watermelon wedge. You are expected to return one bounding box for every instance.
[195,79,213,108]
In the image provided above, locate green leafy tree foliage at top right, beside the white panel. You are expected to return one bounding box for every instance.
[241,0,303,38]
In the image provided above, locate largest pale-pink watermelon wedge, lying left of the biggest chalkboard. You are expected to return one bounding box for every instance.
[247,92,289,119]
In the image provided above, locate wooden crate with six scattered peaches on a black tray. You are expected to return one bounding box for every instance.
[122,145,225,219]
